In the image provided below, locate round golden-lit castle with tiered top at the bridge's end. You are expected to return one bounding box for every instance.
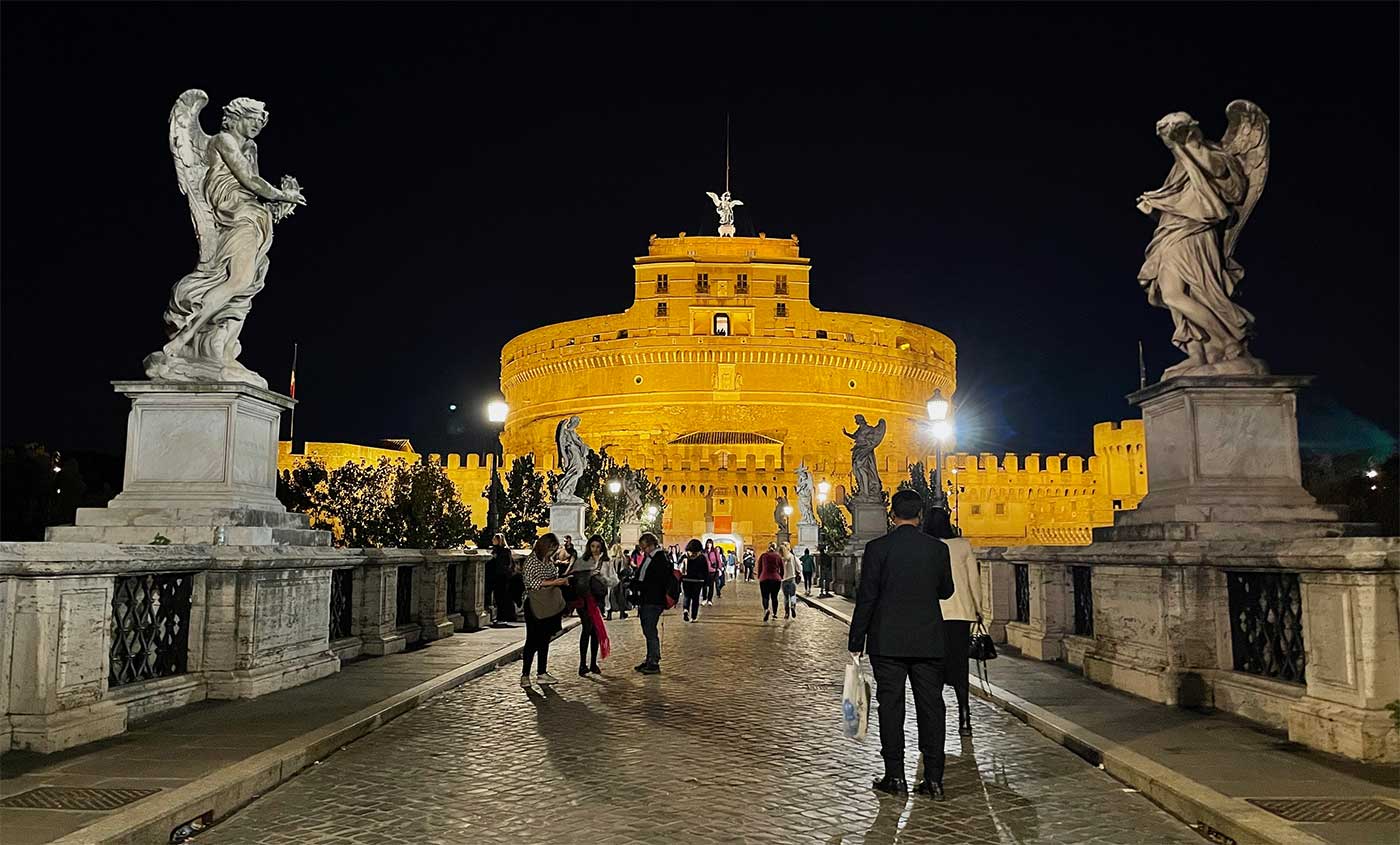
[501,232,956,544]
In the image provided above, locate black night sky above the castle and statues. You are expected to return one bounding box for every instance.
[0,3,1400,453]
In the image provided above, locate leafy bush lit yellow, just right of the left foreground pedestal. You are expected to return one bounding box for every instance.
[277,456,476,548]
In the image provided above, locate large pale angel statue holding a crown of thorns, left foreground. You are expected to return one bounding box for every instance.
[146,88,307,388]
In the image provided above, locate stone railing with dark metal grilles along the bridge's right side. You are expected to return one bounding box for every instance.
[977,537,1400,761]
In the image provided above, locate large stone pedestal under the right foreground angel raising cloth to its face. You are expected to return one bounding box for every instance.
[1096,375,1343,540]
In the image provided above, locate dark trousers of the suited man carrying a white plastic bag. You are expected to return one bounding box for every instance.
[871,655,946,783]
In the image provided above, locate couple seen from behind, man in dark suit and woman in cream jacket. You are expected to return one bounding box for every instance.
[848,490,981,800]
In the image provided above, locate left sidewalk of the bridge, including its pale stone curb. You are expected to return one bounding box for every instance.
[0,618,578,845]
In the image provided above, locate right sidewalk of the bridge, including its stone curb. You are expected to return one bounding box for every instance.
[804,596,1400,845]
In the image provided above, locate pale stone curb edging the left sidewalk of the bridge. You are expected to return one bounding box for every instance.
[49,618,578,845]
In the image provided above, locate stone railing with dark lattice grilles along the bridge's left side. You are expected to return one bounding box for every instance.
[0,543,501,753]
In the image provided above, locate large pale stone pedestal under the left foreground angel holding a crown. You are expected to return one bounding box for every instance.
[45,382,330,546]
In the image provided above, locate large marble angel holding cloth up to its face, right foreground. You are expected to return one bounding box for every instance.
[1137,99,1268,378]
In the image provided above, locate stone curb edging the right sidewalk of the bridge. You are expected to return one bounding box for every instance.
[799,596,1327,845]
